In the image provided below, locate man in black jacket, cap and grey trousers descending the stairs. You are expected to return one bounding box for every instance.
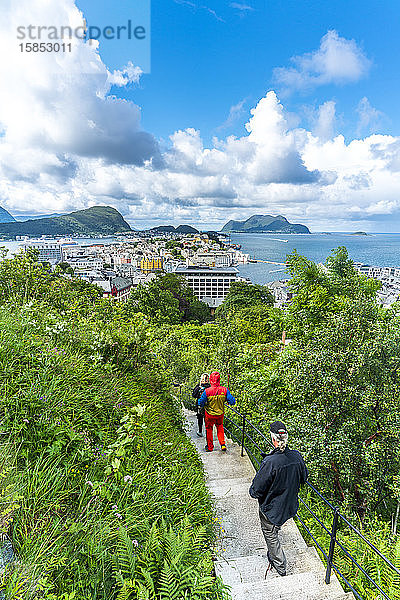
[249,421,308,575]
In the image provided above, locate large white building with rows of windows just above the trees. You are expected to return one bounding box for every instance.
[174,266,238,308]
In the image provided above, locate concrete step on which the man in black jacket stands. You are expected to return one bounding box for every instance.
[214,547,321,586]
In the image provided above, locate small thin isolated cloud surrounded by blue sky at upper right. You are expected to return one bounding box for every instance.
[274,30,371,92]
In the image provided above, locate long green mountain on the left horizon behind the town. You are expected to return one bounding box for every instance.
[0,206,131,237]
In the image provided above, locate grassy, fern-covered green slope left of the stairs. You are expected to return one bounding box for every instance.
[0,254,226,600]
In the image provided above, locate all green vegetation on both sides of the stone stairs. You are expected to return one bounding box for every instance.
[0,248,400,600]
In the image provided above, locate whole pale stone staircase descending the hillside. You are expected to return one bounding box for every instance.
[184,410,354,600]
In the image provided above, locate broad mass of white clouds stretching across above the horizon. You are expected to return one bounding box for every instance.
[0,0,400,229]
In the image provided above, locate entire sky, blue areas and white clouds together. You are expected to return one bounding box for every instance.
[0,0,400,232]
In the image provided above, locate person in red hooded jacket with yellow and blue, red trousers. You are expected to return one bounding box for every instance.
[199,371,236,452]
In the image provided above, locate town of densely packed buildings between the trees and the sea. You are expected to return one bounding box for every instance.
[22,233,250,311]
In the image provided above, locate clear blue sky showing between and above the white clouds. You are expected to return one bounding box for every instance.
[78,0,400,140]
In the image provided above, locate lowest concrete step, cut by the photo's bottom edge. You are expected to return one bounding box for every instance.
[231,571,350,600]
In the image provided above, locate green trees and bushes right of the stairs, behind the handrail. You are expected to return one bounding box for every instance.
[152,248,400,600]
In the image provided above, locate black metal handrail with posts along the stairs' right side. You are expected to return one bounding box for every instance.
[225,404,400,600]
